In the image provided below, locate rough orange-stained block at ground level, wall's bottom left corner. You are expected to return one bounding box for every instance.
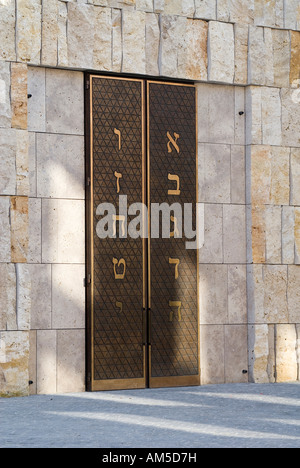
[0,331,29,397]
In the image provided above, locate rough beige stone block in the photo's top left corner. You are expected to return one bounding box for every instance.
[0,0,16,61]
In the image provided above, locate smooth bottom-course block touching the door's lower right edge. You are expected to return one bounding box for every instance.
[200,325,225,385]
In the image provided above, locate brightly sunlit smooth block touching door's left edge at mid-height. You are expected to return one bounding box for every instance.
[42,199,85,263]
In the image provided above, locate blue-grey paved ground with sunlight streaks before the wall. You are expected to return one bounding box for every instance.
[0,383,300,449]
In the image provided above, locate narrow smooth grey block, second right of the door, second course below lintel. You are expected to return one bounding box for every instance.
[231,146,246,204]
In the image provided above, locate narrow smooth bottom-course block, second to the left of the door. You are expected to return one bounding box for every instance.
[36,330,57,395]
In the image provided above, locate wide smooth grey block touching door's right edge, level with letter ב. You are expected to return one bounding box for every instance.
[198,144,231,203]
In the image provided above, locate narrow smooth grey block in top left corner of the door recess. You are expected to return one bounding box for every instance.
[28,67,46,132]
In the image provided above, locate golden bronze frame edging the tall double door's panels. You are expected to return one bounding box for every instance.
[85,74,200,391]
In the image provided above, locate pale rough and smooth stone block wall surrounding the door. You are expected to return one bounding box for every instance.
[0,0,300,395]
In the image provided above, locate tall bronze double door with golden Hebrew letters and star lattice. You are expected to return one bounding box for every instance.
[86,75,200,391]
